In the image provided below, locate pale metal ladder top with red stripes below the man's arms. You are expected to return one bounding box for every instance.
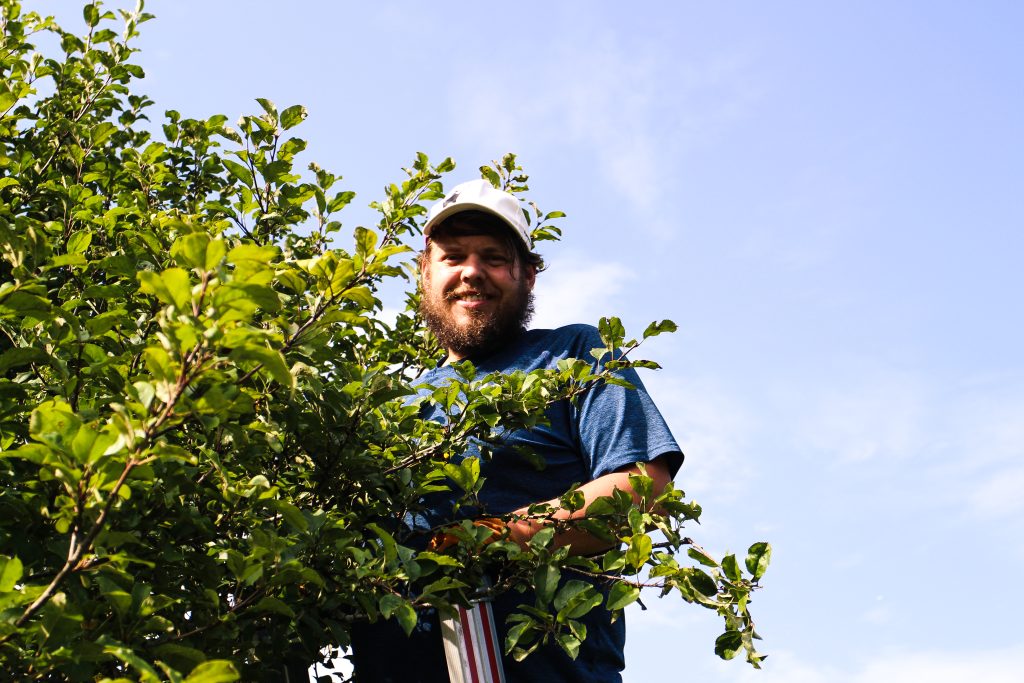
[441,602,505,683]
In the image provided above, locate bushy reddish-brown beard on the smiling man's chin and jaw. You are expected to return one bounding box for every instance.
[420,281,534,357]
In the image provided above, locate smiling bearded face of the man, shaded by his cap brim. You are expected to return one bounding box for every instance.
[420,229,537,360]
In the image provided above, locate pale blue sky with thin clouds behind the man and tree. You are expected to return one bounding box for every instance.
[39,0,1024,683]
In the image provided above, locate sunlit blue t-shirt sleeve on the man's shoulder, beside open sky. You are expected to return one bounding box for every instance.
[574,331,683,478]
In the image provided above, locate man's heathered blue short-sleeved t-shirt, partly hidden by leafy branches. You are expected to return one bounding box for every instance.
[352,325,683,683]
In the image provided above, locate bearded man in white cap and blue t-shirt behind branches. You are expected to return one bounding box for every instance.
[353,180,682,683]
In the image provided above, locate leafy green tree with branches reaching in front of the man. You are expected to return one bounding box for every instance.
[0,0,770,683]
